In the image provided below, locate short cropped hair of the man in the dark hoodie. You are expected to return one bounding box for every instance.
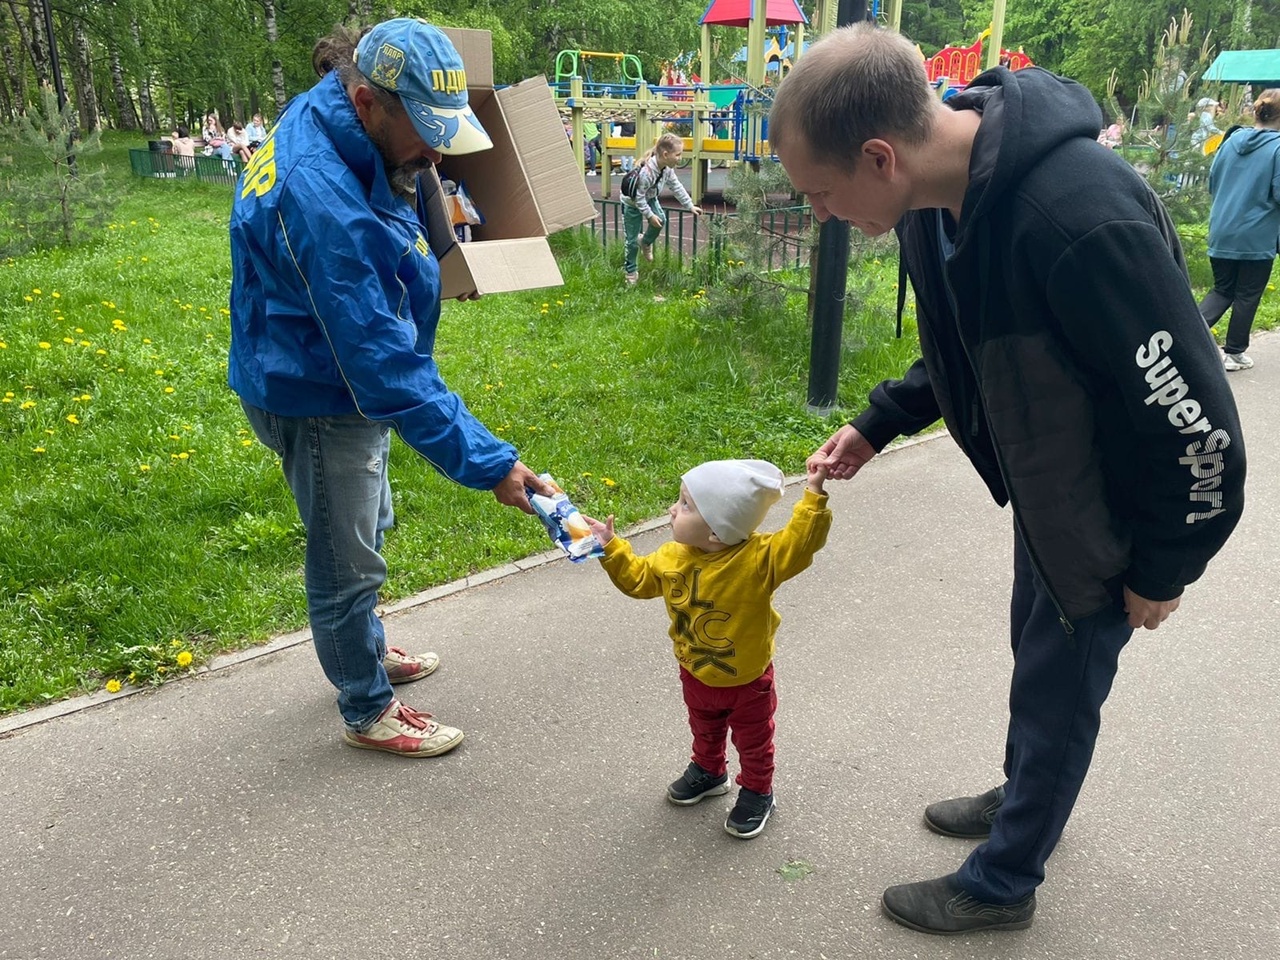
[769,23,940,164]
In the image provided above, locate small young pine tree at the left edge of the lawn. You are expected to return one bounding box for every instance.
[0,84,115,256]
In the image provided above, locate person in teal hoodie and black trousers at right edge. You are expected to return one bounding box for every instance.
[1201,90,1280,370]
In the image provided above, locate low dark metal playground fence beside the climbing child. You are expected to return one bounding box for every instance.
[591,197,813,270]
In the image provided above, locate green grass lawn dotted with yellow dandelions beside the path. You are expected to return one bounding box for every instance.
[0,136,1280,713]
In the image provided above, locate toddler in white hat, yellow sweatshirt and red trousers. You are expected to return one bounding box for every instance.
[584,460,831,840]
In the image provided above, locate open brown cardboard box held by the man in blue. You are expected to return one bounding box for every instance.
[422,27,595,300]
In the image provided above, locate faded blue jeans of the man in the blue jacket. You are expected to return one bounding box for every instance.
[241,403,394,732]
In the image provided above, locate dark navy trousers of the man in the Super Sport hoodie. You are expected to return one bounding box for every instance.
[959,534,1133,904]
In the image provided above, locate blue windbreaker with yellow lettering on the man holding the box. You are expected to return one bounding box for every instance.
[228,73,517,490]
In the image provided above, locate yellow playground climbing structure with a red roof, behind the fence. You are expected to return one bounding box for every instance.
[553,0,808,201]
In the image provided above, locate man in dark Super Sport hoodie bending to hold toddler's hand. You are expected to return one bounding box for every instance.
[769,24,1244,933]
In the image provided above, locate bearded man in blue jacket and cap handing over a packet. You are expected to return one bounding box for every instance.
[228,18,553,756]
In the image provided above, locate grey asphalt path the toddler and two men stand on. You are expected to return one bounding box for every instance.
[0,335,1280,960]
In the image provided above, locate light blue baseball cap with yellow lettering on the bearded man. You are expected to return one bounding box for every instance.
[356,17,493,155]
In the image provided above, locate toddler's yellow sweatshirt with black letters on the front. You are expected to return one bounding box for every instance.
[600,488,831,686]
